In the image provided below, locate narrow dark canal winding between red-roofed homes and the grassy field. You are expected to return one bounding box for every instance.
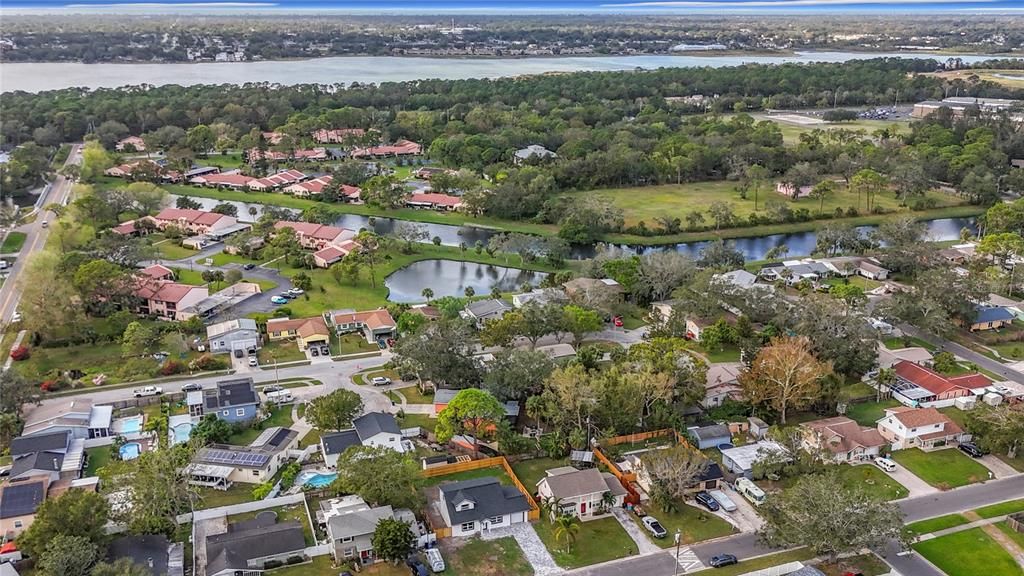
[165,195,977,262]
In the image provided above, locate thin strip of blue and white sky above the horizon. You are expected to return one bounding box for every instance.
[6,0,1024,11]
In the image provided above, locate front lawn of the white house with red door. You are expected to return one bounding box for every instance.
[534,516,637,569]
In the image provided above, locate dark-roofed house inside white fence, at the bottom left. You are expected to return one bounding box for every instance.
[206,513,306,576]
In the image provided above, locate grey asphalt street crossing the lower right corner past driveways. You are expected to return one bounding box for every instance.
[573,475,1024,576]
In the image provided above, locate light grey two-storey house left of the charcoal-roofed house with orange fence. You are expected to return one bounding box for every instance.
[316,495,420,565]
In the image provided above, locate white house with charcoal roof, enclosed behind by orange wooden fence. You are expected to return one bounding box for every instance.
[436,477,530,536]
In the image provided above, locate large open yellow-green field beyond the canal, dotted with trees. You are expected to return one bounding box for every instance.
[579,176,961,228]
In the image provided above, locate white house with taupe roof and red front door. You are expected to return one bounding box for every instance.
[537,466,627,520]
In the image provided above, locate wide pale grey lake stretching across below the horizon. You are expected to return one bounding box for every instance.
[0,52,1005,92]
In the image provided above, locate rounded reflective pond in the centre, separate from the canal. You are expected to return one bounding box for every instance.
[384,260,548,303]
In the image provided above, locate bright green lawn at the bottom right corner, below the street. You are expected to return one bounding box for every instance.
[913,528,1021,576]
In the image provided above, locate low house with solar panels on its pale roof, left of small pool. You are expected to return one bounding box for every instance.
[184,426,299,490]
